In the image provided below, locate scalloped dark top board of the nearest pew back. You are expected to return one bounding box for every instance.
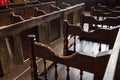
[28,36,111,80]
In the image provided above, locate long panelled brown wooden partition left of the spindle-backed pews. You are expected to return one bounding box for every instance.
[0,4,86,80]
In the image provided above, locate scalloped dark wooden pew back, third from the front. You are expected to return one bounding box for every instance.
[80,14,120,30]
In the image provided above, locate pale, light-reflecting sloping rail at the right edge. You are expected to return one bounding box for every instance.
[103,30,120,80]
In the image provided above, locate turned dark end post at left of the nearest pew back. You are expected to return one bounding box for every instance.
[28,35,38,80]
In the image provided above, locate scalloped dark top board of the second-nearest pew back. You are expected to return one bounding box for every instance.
[65,20,118,48]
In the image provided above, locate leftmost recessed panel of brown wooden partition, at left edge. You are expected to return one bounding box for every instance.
[0,38,14,75]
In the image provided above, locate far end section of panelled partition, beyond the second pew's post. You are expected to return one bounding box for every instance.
[63,3,85,25]
